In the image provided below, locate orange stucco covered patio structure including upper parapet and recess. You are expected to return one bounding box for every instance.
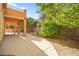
[3,4,26,34]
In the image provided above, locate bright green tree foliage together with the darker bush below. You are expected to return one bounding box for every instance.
[37,3,79,37]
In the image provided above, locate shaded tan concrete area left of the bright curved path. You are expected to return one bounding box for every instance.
[0,35,47,56]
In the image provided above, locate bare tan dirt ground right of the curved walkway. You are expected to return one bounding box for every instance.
[47,39,79,56]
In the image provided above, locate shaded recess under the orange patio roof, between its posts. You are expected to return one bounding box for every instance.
[4,17,26,35]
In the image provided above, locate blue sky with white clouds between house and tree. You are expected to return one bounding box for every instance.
[8,3,39,19]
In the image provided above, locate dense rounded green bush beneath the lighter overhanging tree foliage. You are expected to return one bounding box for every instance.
[39,20,62,37]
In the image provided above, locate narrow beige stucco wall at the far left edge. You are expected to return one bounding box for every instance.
[0,4,4,44]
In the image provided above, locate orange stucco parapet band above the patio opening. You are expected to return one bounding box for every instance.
[4,8,26,20]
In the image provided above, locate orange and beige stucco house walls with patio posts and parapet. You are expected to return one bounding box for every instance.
[0,3,26,42]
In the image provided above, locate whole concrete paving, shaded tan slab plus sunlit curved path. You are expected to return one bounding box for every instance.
[0,34,57,56]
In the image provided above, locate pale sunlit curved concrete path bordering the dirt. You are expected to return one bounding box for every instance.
[21,34,58,56]
